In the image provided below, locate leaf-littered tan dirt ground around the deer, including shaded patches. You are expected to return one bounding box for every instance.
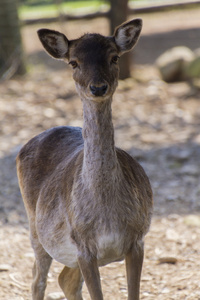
[0,9,200,300]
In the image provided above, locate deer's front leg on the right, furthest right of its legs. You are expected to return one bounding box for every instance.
[126,241,144,300]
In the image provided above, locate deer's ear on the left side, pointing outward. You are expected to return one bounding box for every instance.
[37,29,69,59]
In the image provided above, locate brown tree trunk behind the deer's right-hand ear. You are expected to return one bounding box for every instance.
[110,0,131,79]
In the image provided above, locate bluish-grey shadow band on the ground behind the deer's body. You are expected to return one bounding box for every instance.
[0,139,200,226]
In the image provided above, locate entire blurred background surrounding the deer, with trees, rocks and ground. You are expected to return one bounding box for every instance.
[0,0,200,300]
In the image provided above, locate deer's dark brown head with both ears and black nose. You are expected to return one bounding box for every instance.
[38,19,142,102]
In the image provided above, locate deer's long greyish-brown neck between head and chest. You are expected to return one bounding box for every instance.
[82,99,118,187]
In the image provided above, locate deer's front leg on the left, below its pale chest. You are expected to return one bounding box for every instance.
[78,256,103,300]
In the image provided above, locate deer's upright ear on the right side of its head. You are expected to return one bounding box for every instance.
[114,19,142,54]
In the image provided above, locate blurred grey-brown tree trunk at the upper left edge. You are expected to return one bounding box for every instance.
[0,0,25,79]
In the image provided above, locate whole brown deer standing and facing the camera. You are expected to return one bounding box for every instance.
[17,19,152,300]
